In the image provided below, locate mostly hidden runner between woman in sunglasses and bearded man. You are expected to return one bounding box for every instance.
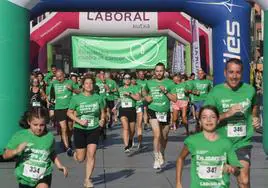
[136,70,150,130]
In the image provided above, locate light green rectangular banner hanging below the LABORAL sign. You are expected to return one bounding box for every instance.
[72,36,167,69]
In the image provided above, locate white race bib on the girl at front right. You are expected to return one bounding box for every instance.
[198,165,222,179]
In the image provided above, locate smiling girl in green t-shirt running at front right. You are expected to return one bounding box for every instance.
[176,106,243,188]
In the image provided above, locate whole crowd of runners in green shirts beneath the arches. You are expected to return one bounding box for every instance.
[3,59,260,188]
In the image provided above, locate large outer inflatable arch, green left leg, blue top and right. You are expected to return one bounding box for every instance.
[0,0,268,152]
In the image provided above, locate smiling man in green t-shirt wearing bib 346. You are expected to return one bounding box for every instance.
[205,59,260,187]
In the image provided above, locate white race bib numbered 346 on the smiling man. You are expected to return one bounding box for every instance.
[227,123,247,137]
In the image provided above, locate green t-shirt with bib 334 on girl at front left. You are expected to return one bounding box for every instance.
[6,129,55,186]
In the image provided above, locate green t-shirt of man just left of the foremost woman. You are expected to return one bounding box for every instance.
[53,80,74,110]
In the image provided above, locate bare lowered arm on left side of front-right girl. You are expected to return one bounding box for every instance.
[176,146,190,188]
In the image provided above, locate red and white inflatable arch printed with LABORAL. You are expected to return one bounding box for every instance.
[30,12,212,74]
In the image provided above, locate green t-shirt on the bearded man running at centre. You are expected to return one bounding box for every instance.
[144,79,175,112]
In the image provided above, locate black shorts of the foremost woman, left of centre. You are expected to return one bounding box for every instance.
[74,127,100,149]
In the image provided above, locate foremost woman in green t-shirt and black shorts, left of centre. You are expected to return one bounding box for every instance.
[67,75,105,187]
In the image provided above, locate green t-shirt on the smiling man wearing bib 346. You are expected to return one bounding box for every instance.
[205,83,256,149]
